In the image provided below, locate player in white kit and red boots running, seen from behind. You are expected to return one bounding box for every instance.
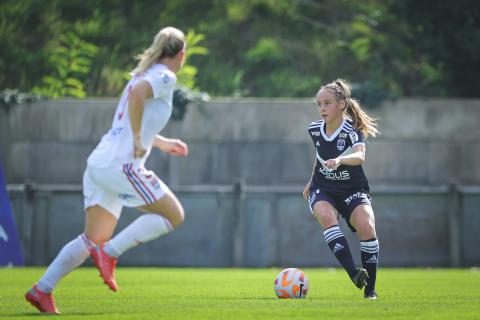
[25,27,188,314]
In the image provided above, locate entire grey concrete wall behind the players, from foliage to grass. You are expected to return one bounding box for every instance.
[0,99,480,267]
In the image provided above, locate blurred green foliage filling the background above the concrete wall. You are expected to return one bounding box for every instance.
[0,0,480,97]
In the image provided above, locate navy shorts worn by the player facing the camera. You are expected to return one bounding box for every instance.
[308,189,372,232]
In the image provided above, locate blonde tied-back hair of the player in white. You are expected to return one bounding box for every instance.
[130,27,185,76]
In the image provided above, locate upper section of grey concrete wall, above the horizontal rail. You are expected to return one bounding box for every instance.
[0,99,480,185]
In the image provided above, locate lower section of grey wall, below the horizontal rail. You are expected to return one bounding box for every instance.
[10,186,480,267]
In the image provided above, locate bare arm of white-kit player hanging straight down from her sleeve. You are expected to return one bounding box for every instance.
[128,80,153,158]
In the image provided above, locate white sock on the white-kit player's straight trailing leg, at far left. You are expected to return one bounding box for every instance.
[37,234,95,293]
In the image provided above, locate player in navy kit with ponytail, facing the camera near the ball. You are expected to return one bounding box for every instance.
[303,79,379,299]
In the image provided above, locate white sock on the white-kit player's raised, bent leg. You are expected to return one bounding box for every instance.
[104,213,173,258]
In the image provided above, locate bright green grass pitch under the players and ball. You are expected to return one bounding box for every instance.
[0,268,480,320]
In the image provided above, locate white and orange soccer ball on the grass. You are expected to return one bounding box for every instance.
[274,268,309,299]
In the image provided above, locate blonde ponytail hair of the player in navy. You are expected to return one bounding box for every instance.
[318,79,380,139]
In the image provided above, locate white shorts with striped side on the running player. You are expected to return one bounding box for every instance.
[83,164,169,219]
